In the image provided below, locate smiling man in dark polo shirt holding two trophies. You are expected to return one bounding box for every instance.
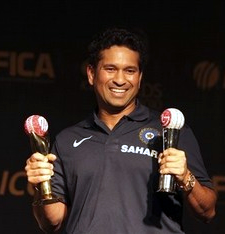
[25,28,216,234]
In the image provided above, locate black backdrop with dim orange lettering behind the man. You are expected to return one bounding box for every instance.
[0,0,225,234]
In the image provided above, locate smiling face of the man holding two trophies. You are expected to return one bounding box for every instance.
[87,46,142,112]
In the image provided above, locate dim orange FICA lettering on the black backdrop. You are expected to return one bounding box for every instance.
[0,51,55,79]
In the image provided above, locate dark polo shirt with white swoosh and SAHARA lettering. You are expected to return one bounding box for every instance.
[52,103,212,234]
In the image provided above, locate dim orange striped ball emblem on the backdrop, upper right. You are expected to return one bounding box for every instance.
[193,61,225,90]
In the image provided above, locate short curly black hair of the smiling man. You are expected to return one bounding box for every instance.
[88,27,148,71]
